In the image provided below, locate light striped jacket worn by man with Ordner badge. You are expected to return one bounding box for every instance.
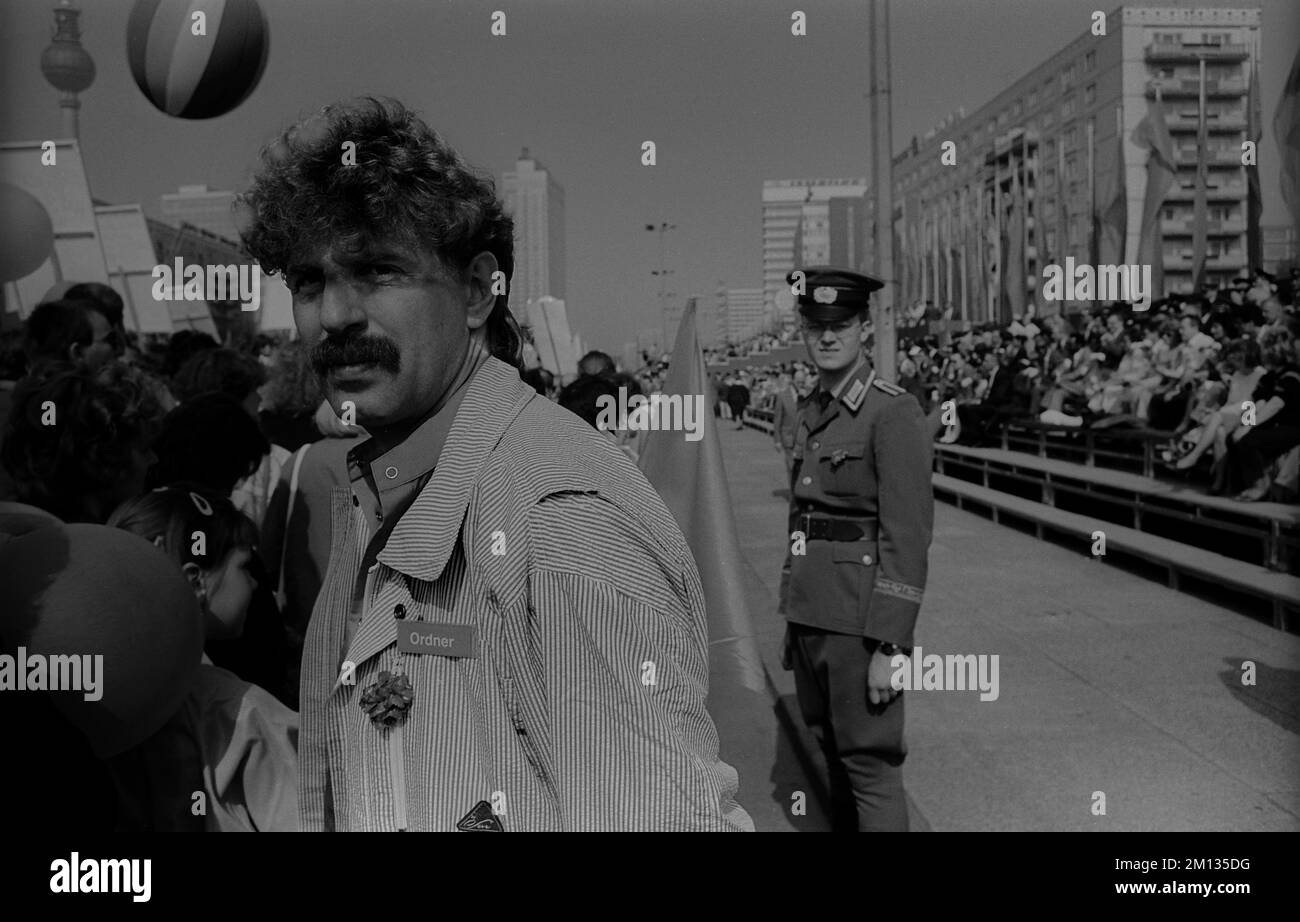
[299,359,753,831]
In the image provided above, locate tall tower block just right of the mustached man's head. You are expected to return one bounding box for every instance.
[502,147,564,311]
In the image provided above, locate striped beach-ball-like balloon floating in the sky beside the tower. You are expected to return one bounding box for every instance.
[126,0,270,118]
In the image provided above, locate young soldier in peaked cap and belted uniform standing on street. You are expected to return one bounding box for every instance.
[781,267,933,832]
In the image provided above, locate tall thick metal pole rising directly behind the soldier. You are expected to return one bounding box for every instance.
[868,0,897,380]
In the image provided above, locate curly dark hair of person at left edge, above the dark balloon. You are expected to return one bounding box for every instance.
[0,362,163,521]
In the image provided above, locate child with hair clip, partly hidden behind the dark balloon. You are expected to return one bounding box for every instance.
[108,484,298,831]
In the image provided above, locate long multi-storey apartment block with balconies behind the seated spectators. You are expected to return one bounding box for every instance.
[893,7,1260,321]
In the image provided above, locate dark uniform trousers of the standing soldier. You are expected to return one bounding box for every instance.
[787,623,907,832]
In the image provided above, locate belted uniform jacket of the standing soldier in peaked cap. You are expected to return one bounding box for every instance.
[781,363,935,648]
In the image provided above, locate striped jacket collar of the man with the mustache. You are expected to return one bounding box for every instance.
[378,358,541,583]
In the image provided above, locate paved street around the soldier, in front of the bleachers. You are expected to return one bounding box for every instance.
[719,423,1300,831]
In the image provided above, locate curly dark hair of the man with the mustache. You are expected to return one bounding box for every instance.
[235,96,523,368]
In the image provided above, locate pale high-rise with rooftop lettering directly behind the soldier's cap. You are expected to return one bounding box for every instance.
[759,179,872,318]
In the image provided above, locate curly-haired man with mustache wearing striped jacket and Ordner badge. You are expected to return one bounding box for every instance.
[239,99,753,831]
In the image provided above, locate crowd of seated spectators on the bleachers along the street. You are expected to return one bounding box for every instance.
[686,270,1300,502]
